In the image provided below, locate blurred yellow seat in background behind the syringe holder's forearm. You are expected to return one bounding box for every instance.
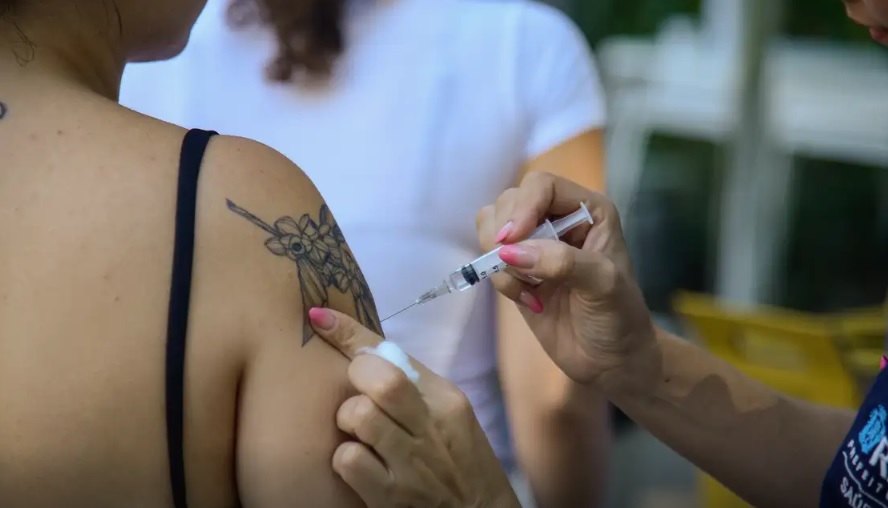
[674,292,886,508]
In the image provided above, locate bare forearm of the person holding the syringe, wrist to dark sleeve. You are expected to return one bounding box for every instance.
[602,332,854,507]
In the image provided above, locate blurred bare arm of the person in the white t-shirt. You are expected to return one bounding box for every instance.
[498,130,610,508]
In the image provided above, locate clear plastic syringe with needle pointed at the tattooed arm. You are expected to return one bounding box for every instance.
[382,203,593,321]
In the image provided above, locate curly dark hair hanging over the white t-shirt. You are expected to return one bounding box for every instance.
[224,0,347,81]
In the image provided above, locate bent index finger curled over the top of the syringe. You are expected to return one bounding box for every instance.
[496,171,617,243]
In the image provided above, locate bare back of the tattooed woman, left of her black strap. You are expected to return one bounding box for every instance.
[0,85,192,506]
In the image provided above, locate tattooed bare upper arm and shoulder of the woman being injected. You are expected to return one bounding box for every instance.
[201,138,379,508]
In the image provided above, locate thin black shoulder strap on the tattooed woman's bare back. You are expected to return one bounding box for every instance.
[166,129,216,508]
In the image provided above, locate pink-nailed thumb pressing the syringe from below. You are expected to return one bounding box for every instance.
[499,240,620,297]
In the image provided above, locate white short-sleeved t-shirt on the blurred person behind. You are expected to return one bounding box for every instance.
[121,0,605,466]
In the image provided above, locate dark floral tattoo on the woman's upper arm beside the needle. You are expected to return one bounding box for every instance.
[227,199,382,346]
